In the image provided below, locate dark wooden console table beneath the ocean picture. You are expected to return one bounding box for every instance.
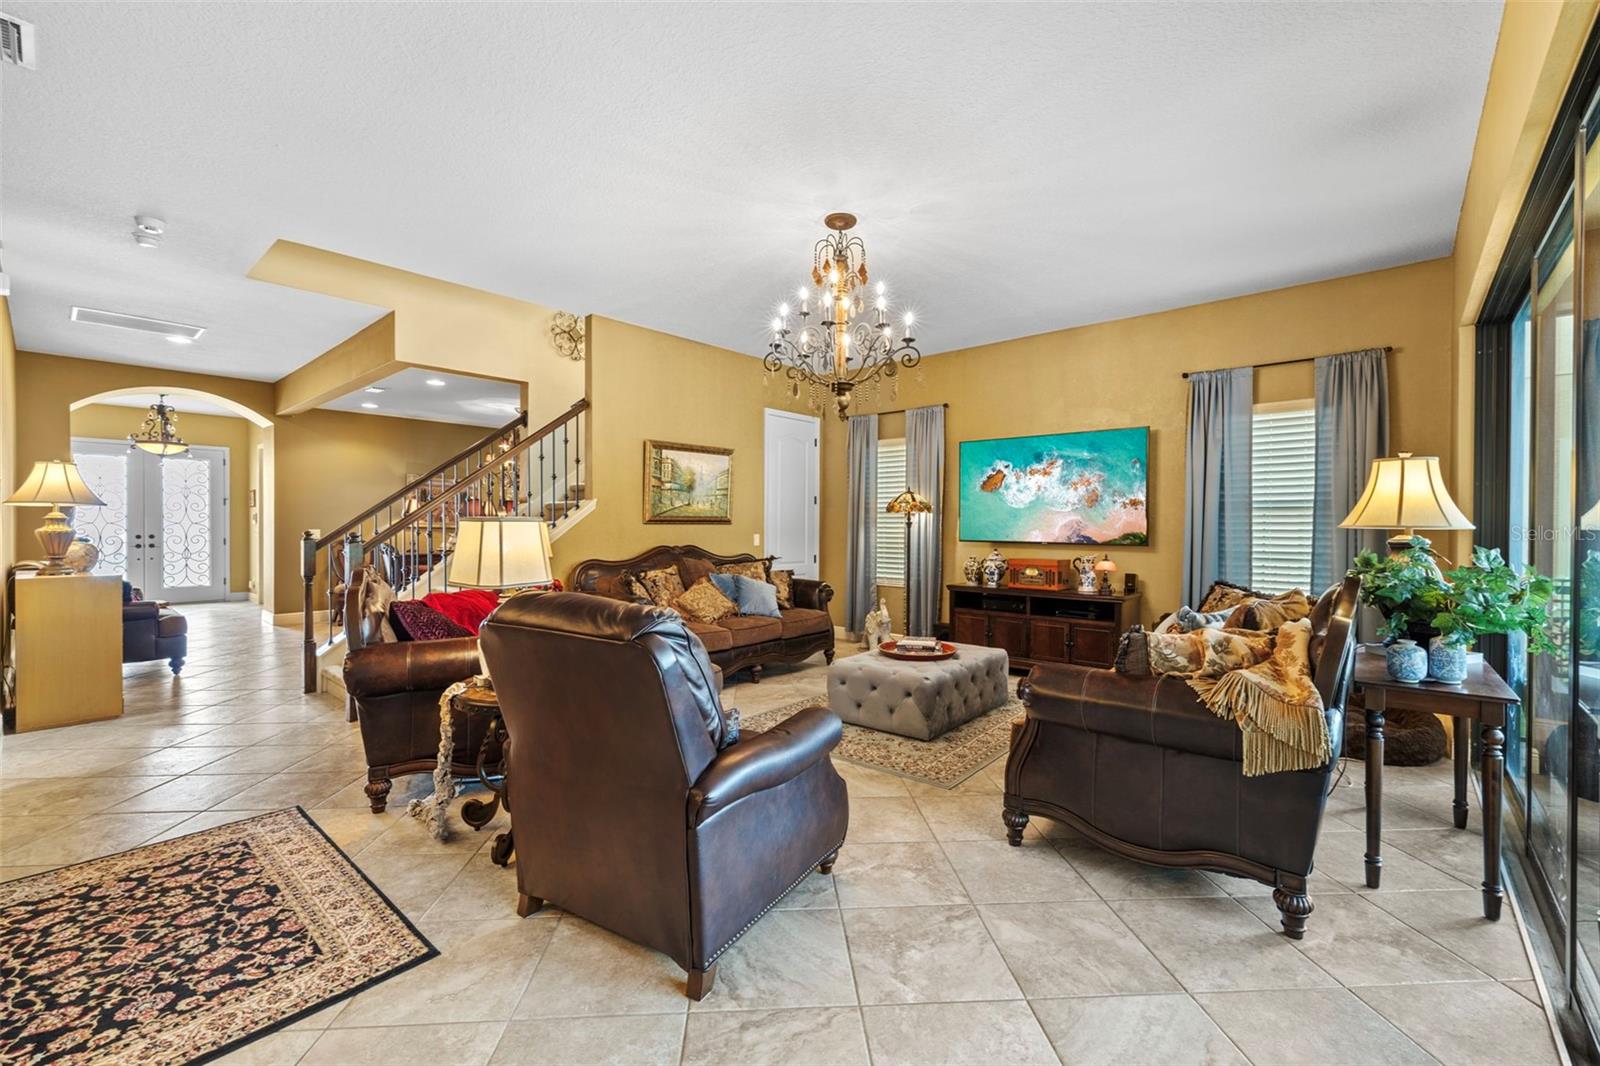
[947,584,1139,669]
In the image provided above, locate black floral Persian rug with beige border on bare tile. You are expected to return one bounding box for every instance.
[0,807,438,1066]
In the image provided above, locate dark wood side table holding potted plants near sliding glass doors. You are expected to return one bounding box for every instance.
[1355,645,1522,920]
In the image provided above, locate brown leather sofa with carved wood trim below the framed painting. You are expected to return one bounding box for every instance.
[570,544,834,682]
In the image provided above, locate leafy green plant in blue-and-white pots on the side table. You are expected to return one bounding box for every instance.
[1352,536,1557,683]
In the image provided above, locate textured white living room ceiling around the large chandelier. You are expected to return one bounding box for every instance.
[3,0,1499,369]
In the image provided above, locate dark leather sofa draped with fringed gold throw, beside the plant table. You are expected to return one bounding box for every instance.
[1003,578,1360,940]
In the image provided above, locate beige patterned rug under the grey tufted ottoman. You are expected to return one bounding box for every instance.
[739,699,1027,789]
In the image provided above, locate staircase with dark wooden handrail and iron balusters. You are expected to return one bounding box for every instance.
[301,400,594,691]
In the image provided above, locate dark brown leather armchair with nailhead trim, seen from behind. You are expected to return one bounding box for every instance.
[478,592,850,1000]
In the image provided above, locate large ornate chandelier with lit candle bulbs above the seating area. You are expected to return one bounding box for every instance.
[762,211,922,421]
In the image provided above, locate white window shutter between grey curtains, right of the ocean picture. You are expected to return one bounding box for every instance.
[1250,400,1317,592]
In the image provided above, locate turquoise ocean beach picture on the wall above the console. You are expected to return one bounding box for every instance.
[960,426,1150,544]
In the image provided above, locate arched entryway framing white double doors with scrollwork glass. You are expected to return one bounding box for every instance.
[69,386,274,603]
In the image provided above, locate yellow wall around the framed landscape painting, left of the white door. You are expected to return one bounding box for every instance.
[555,317,806,579]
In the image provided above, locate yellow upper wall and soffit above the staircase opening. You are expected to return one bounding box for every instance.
[250,240,584,426]
